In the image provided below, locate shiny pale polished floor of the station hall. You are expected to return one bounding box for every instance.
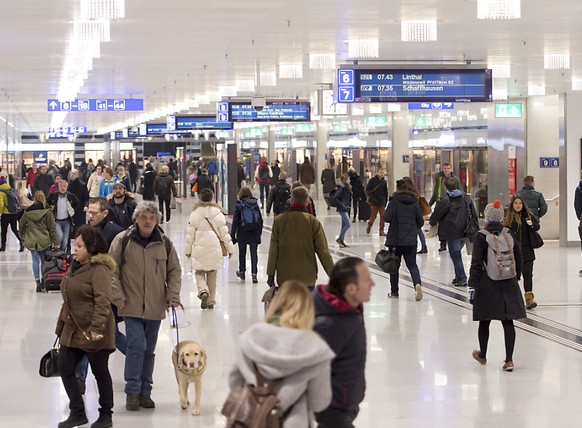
[0,198,582,428]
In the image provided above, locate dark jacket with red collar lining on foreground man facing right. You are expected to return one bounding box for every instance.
[313,285,366,411]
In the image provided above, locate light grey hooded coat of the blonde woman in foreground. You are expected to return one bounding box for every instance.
[229,323,334,428]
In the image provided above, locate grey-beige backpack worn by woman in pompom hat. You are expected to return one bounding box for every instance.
[479,227,517,281]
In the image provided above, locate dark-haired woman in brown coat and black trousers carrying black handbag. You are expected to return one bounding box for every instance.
[56,226,116,428]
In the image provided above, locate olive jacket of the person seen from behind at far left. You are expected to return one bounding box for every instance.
[18,203,59,251]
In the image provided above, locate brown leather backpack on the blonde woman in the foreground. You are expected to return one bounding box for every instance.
[221,363,293,428]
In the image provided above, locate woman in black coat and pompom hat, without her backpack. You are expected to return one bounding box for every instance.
[469,201,526,371]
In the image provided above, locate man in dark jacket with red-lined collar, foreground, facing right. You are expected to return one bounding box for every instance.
[314,257,374,428]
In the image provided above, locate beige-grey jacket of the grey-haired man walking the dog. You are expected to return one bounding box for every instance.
[109,226,182,320]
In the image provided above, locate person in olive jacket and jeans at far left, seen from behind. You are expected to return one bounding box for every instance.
[18,190,59,293]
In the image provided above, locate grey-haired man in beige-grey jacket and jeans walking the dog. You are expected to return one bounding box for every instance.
[109,201,182,411]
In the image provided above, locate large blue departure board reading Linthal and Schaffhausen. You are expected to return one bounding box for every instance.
[337,68,493,103]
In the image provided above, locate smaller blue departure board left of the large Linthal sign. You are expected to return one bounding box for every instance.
[217,101,311,122]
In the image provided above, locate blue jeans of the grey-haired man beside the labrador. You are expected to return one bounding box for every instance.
[123,317,161,396]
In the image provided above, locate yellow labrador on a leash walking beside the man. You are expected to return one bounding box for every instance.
[172,340,206,416]
